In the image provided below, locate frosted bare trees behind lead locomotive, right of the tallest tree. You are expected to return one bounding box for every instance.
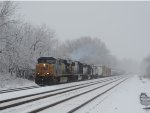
[10,23,56,78]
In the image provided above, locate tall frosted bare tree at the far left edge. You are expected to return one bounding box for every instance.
[0,1,16,72]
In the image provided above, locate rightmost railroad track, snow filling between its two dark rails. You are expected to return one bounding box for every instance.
[27,76,126,113]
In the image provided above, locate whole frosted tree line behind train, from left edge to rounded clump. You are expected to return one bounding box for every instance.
[0,1,136,79]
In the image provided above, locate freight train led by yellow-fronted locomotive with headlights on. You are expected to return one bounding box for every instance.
[35,57,111,86]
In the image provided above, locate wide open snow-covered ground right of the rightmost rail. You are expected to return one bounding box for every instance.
[76,75,150,113]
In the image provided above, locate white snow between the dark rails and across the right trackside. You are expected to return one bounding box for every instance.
[1,75,150,113]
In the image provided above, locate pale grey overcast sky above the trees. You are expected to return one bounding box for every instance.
[19,1,150,61]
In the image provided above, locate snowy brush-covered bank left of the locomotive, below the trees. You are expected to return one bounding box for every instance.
[0,73,36,90]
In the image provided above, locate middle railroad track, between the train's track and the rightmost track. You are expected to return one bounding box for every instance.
[0,78,118,110]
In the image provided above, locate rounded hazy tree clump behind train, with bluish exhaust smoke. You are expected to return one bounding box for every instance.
[58,37,117,67]
